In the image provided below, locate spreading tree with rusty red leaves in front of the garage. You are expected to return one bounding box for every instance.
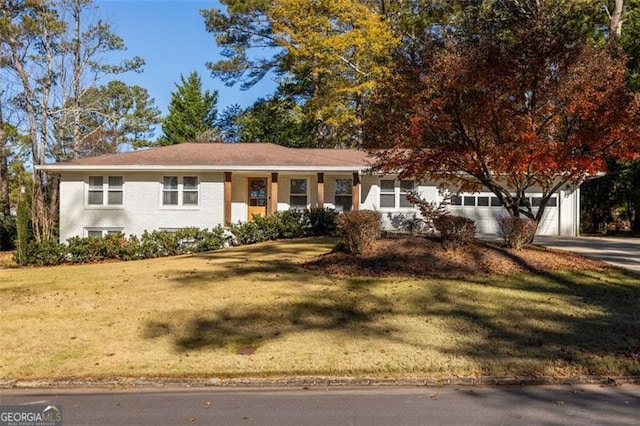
[368,1,639,226]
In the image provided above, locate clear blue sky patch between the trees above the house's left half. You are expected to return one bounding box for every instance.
[95,0,275,115]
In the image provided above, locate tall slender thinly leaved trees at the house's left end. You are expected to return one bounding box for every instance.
[0,0,144,240]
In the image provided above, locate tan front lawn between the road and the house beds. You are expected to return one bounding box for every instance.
[0,239,640,380]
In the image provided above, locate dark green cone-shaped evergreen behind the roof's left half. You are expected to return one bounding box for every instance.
[158,71,218,145]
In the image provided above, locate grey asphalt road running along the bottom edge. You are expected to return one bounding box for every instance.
[0,385,640,426]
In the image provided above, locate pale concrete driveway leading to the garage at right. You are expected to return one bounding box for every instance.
[533,236,640,274]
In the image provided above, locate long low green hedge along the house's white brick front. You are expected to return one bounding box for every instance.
[15,209,336,266]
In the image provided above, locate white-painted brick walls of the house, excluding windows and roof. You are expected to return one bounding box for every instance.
[60,173,579,242]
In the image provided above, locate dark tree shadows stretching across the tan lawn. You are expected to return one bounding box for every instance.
[144,240,640,375]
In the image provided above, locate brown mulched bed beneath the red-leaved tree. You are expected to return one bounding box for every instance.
[304,236,608,278]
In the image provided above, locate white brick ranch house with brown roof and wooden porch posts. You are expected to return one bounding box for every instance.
[39,143,579,242]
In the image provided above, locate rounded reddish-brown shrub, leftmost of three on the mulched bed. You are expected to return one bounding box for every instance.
[336,210,381,254]
